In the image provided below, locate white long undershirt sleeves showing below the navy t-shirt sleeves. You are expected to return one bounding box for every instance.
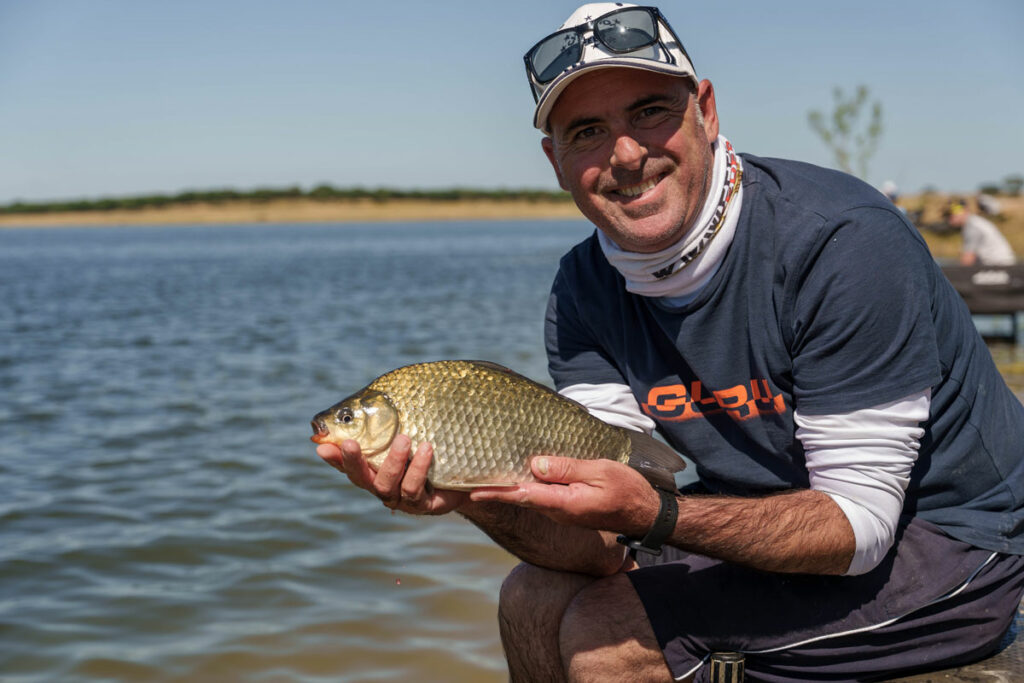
[561,383,931,575]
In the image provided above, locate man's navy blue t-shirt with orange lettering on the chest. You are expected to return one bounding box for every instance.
[546,155,1024,553]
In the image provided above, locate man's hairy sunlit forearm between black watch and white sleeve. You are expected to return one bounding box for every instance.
[669,490,856,574]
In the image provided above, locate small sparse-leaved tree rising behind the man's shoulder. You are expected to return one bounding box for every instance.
[807,85,882,178]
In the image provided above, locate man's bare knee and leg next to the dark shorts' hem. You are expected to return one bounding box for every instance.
[559,573,673,683]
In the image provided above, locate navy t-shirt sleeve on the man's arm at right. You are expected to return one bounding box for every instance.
[787,207,941,416]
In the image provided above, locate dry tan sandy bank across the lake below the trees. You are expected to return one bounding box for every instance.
[0,199,583,229]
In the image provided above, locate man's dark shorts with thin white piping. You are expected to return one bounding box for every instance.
[627,518,1024,681]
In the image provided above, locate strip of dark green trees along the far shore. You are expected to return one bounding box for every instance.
[0,184,571,215]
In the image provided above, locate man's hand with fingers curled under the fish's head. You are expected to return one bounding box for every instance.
[316,434,469,515]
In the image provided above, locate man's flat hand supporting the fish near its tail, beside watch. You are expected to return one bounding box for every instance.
[470,456,660,536]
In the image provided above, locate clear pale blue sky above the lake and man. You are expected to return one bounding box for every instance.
[0,0,1024,204]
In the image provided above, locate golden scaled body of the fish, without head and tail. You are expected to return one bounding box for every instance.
[369,360,630,488]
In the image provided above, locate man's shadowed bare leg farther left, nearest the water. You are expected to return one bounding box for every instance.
[498,562,595,683]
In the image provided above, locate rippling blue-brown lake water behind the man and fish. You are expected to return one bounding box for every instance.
[0,221,1024,682]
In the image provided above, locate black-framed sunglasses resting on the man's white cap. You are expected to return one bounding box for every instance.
[523,7,689,101]
